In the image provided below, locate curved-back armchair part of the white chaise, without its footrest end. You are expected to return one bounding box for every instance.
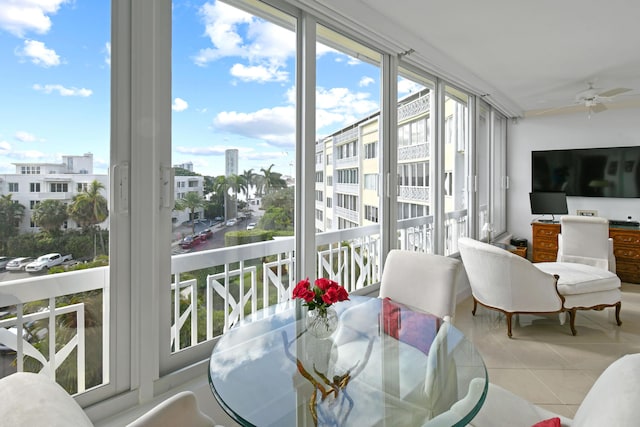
[458,237,564,337]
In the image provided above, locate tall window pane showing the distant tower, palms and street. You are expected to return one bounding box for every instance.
[165,0,298,370]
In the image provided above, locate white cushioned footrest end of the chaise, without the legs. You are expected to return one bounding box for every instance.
[534,262,620,295]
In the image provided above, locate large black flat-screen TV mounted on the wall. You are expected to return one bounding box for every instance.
[531,146,640,197]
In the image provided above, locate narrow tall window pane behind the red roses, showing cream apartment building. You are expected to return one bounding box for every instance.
[315,25,382,290]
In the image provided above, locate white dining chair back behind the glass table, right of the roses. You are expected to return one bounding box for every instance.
[379,249,463,320]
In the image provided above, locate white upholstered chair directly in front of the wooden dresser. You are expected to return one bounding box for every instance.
[556,215,616,273]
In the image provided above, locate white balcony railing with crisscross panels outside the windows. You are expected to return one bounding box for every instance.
[0,210,466,393]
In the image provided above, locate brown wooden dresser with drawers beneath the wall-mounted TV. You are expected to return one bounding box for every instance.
[531,222,640,283]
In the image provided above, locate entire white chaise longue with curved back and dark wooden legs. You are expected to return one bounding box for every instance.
[458,237,622,337]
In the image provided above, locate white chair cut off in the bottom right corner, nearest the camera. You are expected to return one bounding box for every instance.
[469,353,640,427]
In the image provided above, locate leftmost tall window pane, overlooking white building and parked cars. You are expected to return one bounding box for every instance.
[0,1,115,400]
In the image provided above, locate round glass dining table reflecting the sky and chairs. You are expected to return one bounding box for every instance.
[209,295,488,427]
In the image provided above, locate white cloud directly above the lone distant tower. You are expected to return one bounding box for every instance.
[213,106,296,147]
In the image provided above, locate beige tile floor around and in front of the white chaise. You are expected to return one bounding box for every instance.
[454,283,640,418]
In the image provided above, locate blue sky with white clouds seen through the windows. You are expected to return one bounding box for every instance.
[0,0,420,176]
